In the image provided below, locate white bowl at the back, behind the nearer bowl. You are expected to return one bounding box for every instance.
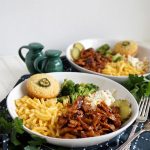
[66,39,150,82]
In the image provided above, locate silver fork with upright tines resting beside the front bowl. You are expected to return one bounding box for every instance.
[120,96,150,150]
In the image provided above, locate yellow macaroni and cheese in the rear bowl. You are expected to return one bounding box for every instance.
[102,60,144,76]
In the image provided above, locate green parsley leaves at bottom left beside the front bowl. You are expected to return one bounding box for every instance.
[0,109,46,150]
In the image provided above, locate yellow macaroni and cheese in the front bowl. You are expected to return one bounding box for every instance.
[16,96,65,137]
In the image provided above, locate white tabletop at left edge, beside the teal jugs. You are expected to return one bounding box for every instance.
[0,56,29,101]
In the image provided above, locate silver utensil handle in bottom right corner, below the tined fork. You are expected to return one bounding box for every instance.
[117,121,150,150]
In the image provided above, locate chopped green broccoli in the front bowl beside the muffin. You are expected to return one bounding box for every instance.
[60,79,99,103]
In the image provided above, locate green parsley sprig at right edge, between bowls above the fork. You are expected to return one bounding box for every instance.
[123,75,150,102]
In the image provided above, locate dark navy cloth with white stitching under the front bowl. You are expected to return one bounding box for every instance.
[0,56,150,150]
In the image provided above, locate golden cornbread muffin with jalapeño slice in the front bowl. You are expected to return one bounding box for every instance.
[26,74,60,98]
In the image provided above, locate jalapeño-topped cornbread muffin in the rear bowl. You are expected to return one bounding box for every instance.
[113,41,138,56]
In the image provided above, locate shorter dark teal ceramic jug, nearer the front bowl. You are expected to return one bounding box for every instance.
[34,50,63,73]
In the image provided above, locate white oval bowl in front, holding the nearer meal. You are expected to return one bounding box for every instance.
[7,72,138,147]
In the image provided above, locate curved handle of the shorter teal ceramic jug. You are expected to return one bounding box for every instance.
[34,56,47,73]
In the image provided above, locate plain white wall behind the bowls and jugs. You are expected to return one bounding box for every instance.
[0,0,150,56]
